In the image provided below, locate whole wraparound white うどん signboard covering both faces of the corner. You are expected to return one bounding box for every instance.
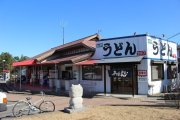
[93,35,177,60]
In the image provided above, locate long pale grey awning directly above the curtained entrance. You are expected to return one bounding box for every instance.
[96,56,143,64]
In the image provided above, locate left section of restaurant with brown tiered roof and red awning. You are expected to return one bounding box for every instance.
[13,34,99,91]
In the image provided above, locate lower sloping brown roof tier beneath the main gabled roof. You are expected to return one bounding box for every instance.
[40,53,92,64]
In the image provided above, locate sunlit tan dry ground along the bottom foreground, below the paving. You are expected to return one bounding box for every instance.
[14,106,180,120]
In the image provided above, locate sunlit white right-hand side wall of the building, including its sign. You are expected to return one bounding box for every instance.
[147,36,177,95]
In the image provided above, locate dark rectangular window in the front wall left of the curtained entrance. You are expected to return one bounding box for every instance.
[82,65,102,80]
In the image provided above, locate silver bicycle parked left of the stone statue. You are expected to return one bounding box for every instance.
[12,91,55,117]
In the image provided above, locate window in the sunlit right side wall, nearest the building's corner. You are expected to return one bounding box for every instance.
[151,63,164,80]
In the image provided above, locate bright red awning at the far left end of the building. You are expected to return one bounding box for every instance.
[13,59,36,67]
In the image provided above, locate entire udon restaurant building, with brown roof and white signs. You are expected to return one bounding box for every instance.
[14,34,177,95]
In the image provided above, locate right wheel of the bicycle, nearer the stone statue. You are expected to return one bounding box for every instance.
[39,101,55,112]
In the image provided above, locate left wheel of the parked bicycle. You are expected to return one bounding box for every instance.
[12,101,30,117]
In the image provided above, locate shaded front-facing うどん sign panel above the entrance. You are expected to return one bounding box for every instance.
[93,36,146,59]
